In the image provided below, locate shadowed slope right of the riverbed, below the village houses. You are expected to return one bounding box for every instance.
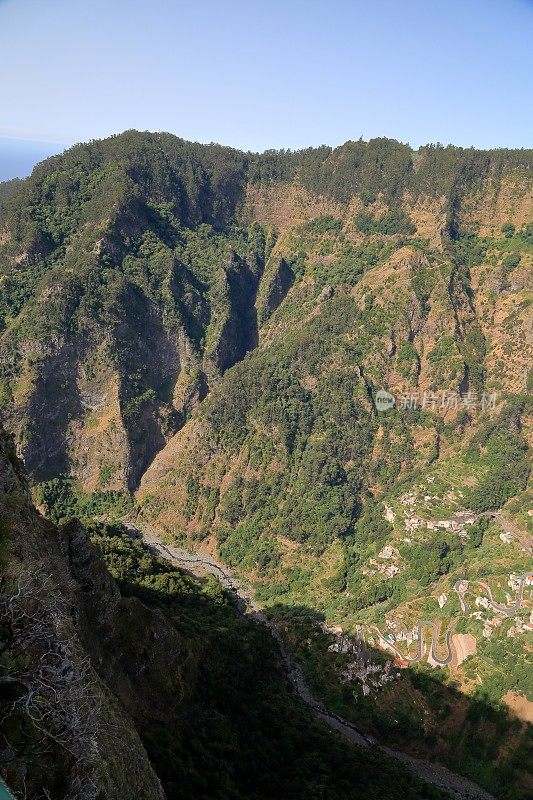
[268,604,533,800]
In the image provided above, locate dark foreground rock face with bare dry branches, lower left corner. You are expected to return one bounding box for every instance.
[0,431,164,800]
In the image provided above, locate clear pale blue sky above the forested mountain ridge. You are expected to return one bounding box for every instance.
[0,0,533,177]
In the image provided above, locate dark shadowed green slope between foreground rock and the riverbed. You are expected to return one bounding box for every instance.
[70,531,448,800]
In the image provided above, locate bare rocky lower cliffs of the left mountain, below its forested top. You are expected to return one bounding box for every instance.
[2,231,261,490]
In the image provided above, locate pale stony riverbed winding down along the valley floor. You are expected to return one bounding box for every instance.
[125,523,496,800]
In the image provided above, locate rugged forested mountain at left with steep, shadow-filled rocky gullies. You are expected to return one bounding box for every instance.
[0,137,264,490]
